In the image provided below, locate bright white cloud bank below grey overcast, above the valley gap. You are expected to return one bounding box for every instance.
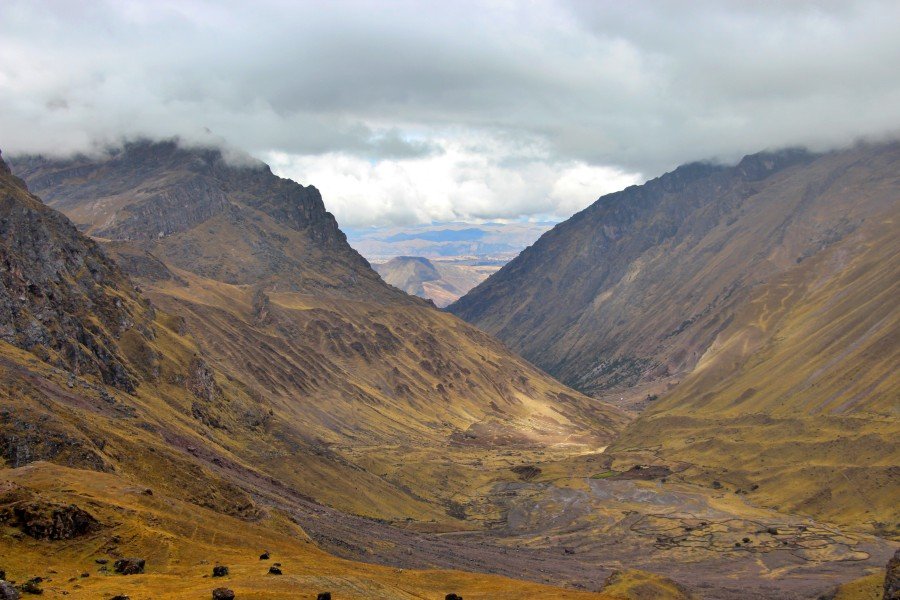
[263,134,641,227]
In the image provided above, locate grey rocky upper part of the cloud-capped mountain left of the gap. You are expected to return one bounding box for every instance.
[13,141,390,298]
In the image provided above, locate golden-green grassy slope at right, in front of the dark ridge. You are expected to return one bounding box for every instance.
[612,220,900,539]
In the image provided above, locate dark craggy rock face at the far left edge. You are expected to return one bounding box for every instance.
[0,152,149,391]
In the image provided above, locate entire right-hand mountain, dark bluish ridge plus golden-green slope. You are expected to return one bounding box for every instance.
[449,143,900,536]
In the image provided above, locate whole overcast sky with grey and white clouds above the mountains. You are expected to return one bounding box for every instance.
[0,0,900,227]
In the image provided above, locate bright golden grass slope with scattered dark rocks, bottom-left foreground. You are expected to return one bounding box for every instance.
[0,462,628,600]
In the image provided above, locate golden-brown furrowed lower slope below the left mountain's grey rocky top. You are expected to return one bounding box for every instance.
[137,264,628,524]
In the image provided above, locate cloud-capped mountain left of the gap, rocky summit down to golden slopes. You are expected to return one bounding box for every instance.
[12,142,627,521]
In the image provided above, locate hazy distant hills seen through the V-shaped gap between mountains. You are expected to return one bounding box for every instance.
[372,256,499,307]
